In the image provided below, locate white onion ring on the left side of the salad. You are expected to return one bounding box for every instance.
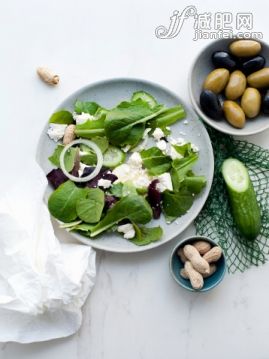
[60,139,104,182]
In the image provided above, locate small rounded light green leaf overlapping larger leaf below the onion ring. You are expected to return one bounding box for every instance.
[76,188,105,223]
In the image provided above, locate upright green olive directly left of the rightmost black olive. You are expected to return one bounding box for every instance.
[241,87,261,118]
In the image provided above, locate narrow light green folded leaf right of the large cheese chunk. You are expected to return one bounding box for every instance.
[171,153,198,191]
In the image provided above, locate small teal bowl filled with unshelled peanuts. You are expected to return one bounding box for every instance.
[170,236,226,292]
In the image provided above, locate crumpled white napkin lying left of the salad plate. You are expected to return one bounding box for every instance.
[0,163,95,343]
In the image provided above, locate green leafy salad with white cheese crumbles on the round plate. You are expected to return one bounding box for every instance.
[47,91,206,245]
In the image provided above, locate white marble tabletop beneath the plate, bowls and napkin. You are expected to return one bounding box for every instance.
[0,0,269,359]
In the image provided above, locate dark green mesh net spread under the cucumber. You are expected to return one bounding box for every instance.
[195,127,269,273]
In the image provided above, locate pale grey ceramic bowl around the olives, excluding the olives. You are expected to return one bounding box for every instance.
[189,39,269,136]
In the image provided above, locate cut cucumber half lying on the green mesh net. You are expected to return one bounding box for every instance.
[221,158,261,239]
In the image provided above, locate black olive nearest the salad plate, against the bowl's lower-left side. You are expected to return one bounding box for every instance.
[200,90,222,120]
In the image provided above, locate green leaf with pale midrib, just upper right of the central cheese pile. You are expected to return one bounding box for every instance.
[140,147,172,176]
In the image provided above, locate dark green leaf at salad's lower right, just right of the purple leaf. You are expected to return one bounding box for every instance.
[162,188,194,220]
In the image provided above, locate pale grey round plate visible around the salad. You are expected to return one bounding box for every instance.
[37,79,214,253]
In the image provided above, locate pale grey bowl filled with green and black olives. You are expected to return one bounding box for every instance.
[189,39,269,136]
